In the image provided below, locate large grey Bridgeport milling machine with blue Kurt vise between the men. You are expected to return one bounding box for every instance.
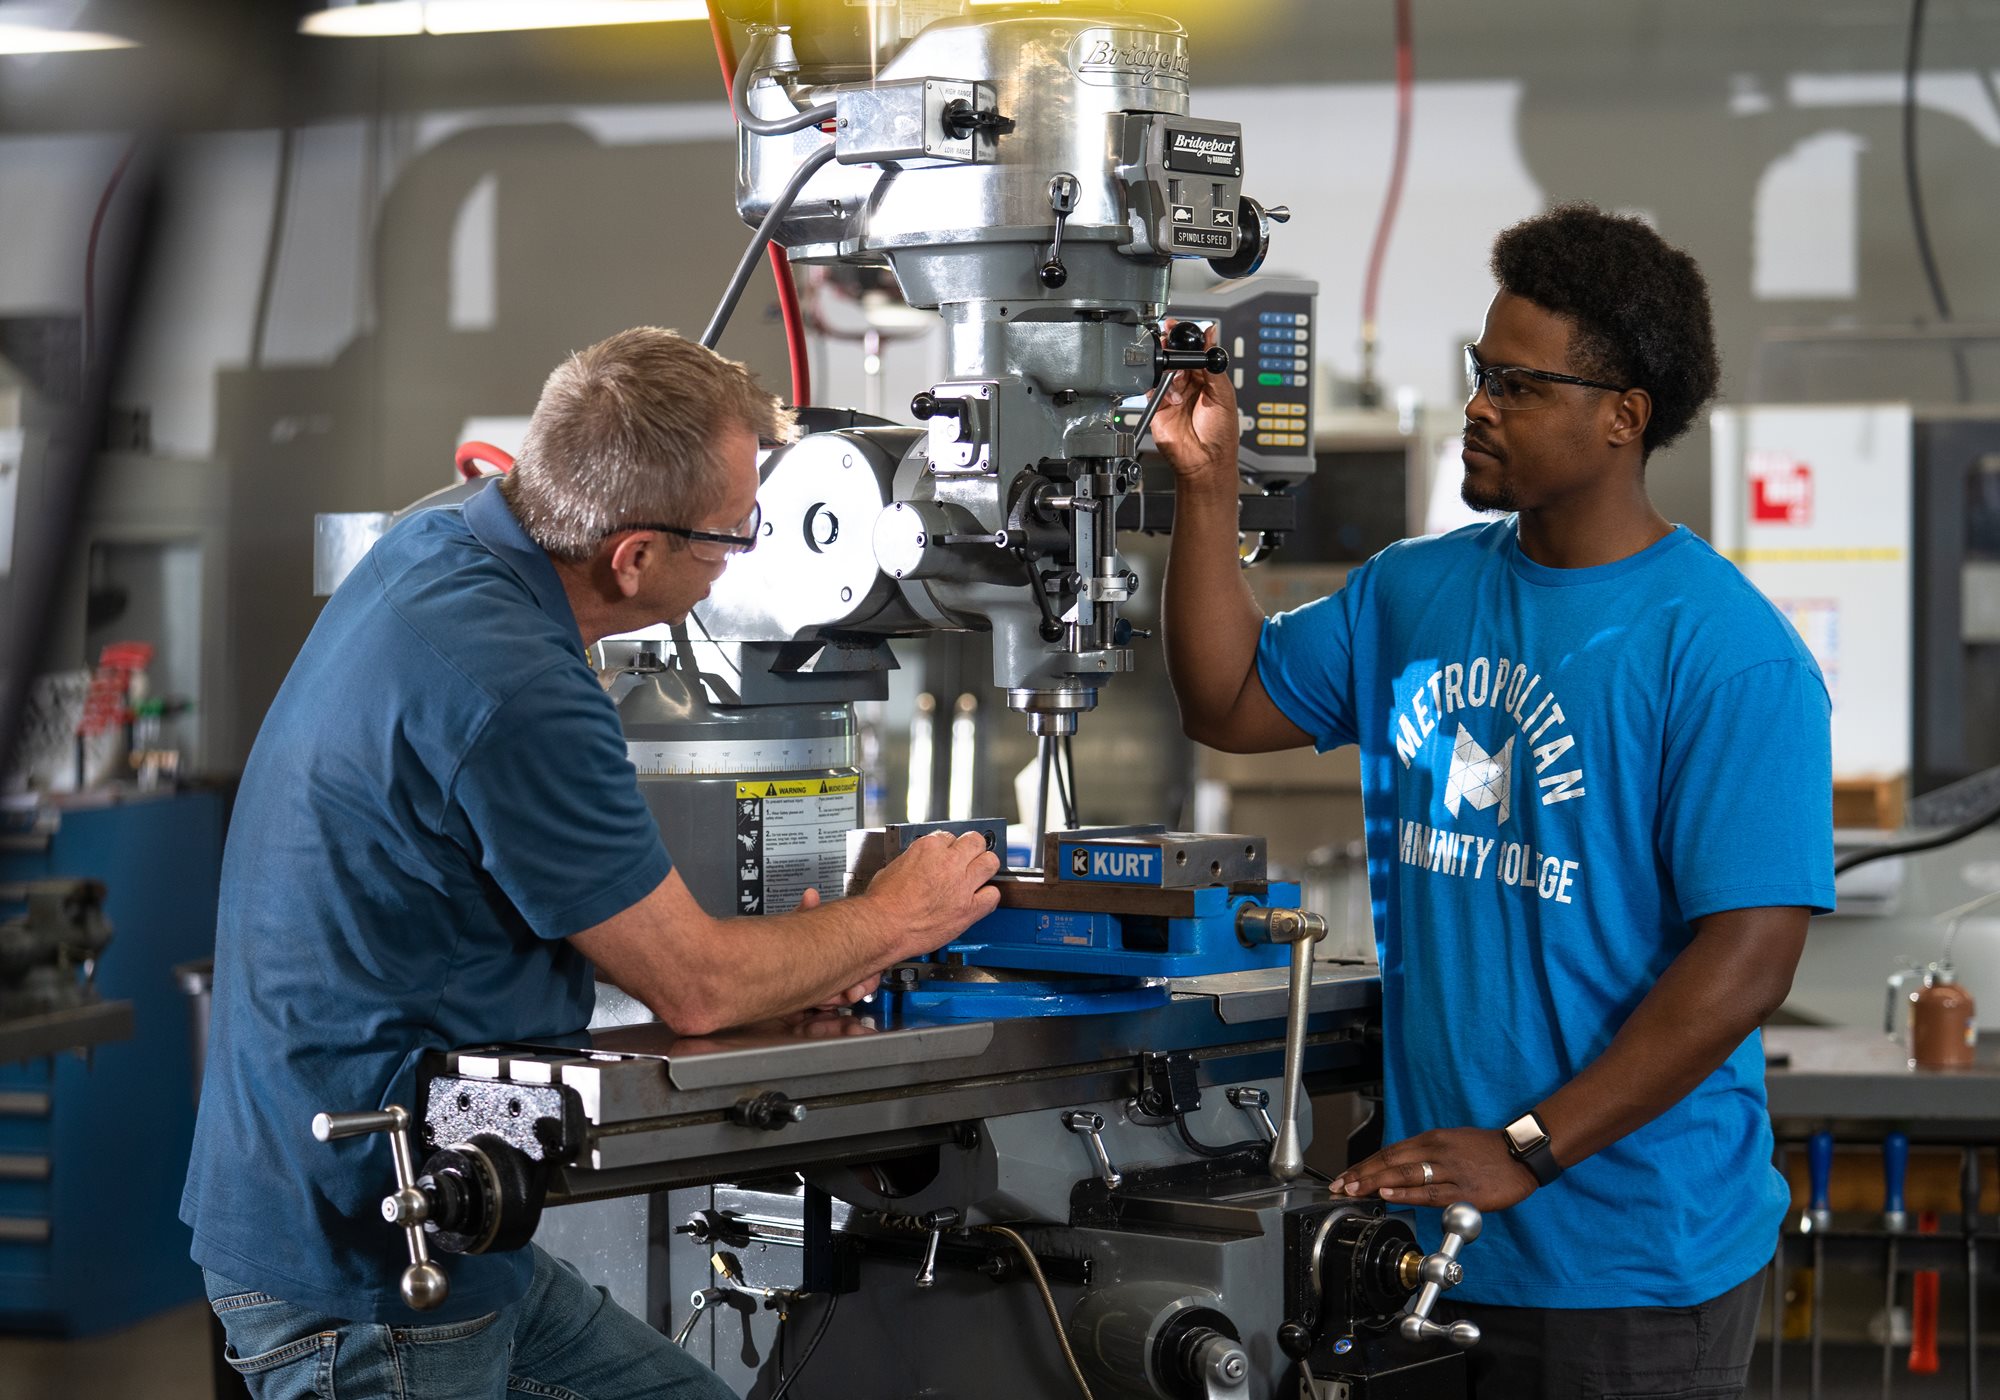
[312,0,1480,1400]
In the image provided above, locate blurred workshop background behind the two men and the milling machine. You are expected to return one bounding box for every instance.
[0,0,2000,1400]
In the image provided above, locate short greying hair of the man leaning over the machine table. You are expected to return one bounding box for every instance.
[500,326,794,564]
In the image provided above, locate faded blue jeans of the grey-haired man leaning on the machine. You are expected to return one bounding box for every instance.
[204,1246,734,1400]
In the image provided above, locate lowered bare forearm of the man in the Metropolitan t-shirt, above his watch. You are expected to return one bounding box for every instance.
[1528,910,1806,1166]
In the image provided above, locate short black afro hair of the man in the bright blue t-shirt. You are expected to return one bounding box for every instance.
[1492,204,1722,456]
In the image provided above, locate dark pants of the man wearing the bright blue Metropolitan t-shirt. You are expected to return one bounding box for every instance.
[1436,1272,1764,1400]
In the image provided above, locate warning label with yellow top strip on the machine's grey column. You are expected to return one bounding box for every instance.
[736,774,860,914]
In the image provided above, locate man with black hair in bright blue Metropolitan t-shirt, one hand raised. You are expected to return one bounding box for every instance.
[1154,206,1834,1400]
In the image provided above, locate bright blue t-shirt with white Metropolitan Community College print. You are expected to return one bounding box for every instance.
[1258,518,1834,1308]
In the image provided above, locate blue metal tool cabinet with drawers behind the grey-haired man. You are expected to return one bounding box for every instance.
[0,792,227,1336]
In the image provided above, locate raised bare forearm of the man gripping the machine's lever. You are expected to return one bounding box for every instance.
[1164,482,1264,742]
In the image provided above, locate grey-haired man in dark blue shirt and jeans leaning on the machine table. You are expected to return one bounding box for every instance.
[180,328,998,1400]
